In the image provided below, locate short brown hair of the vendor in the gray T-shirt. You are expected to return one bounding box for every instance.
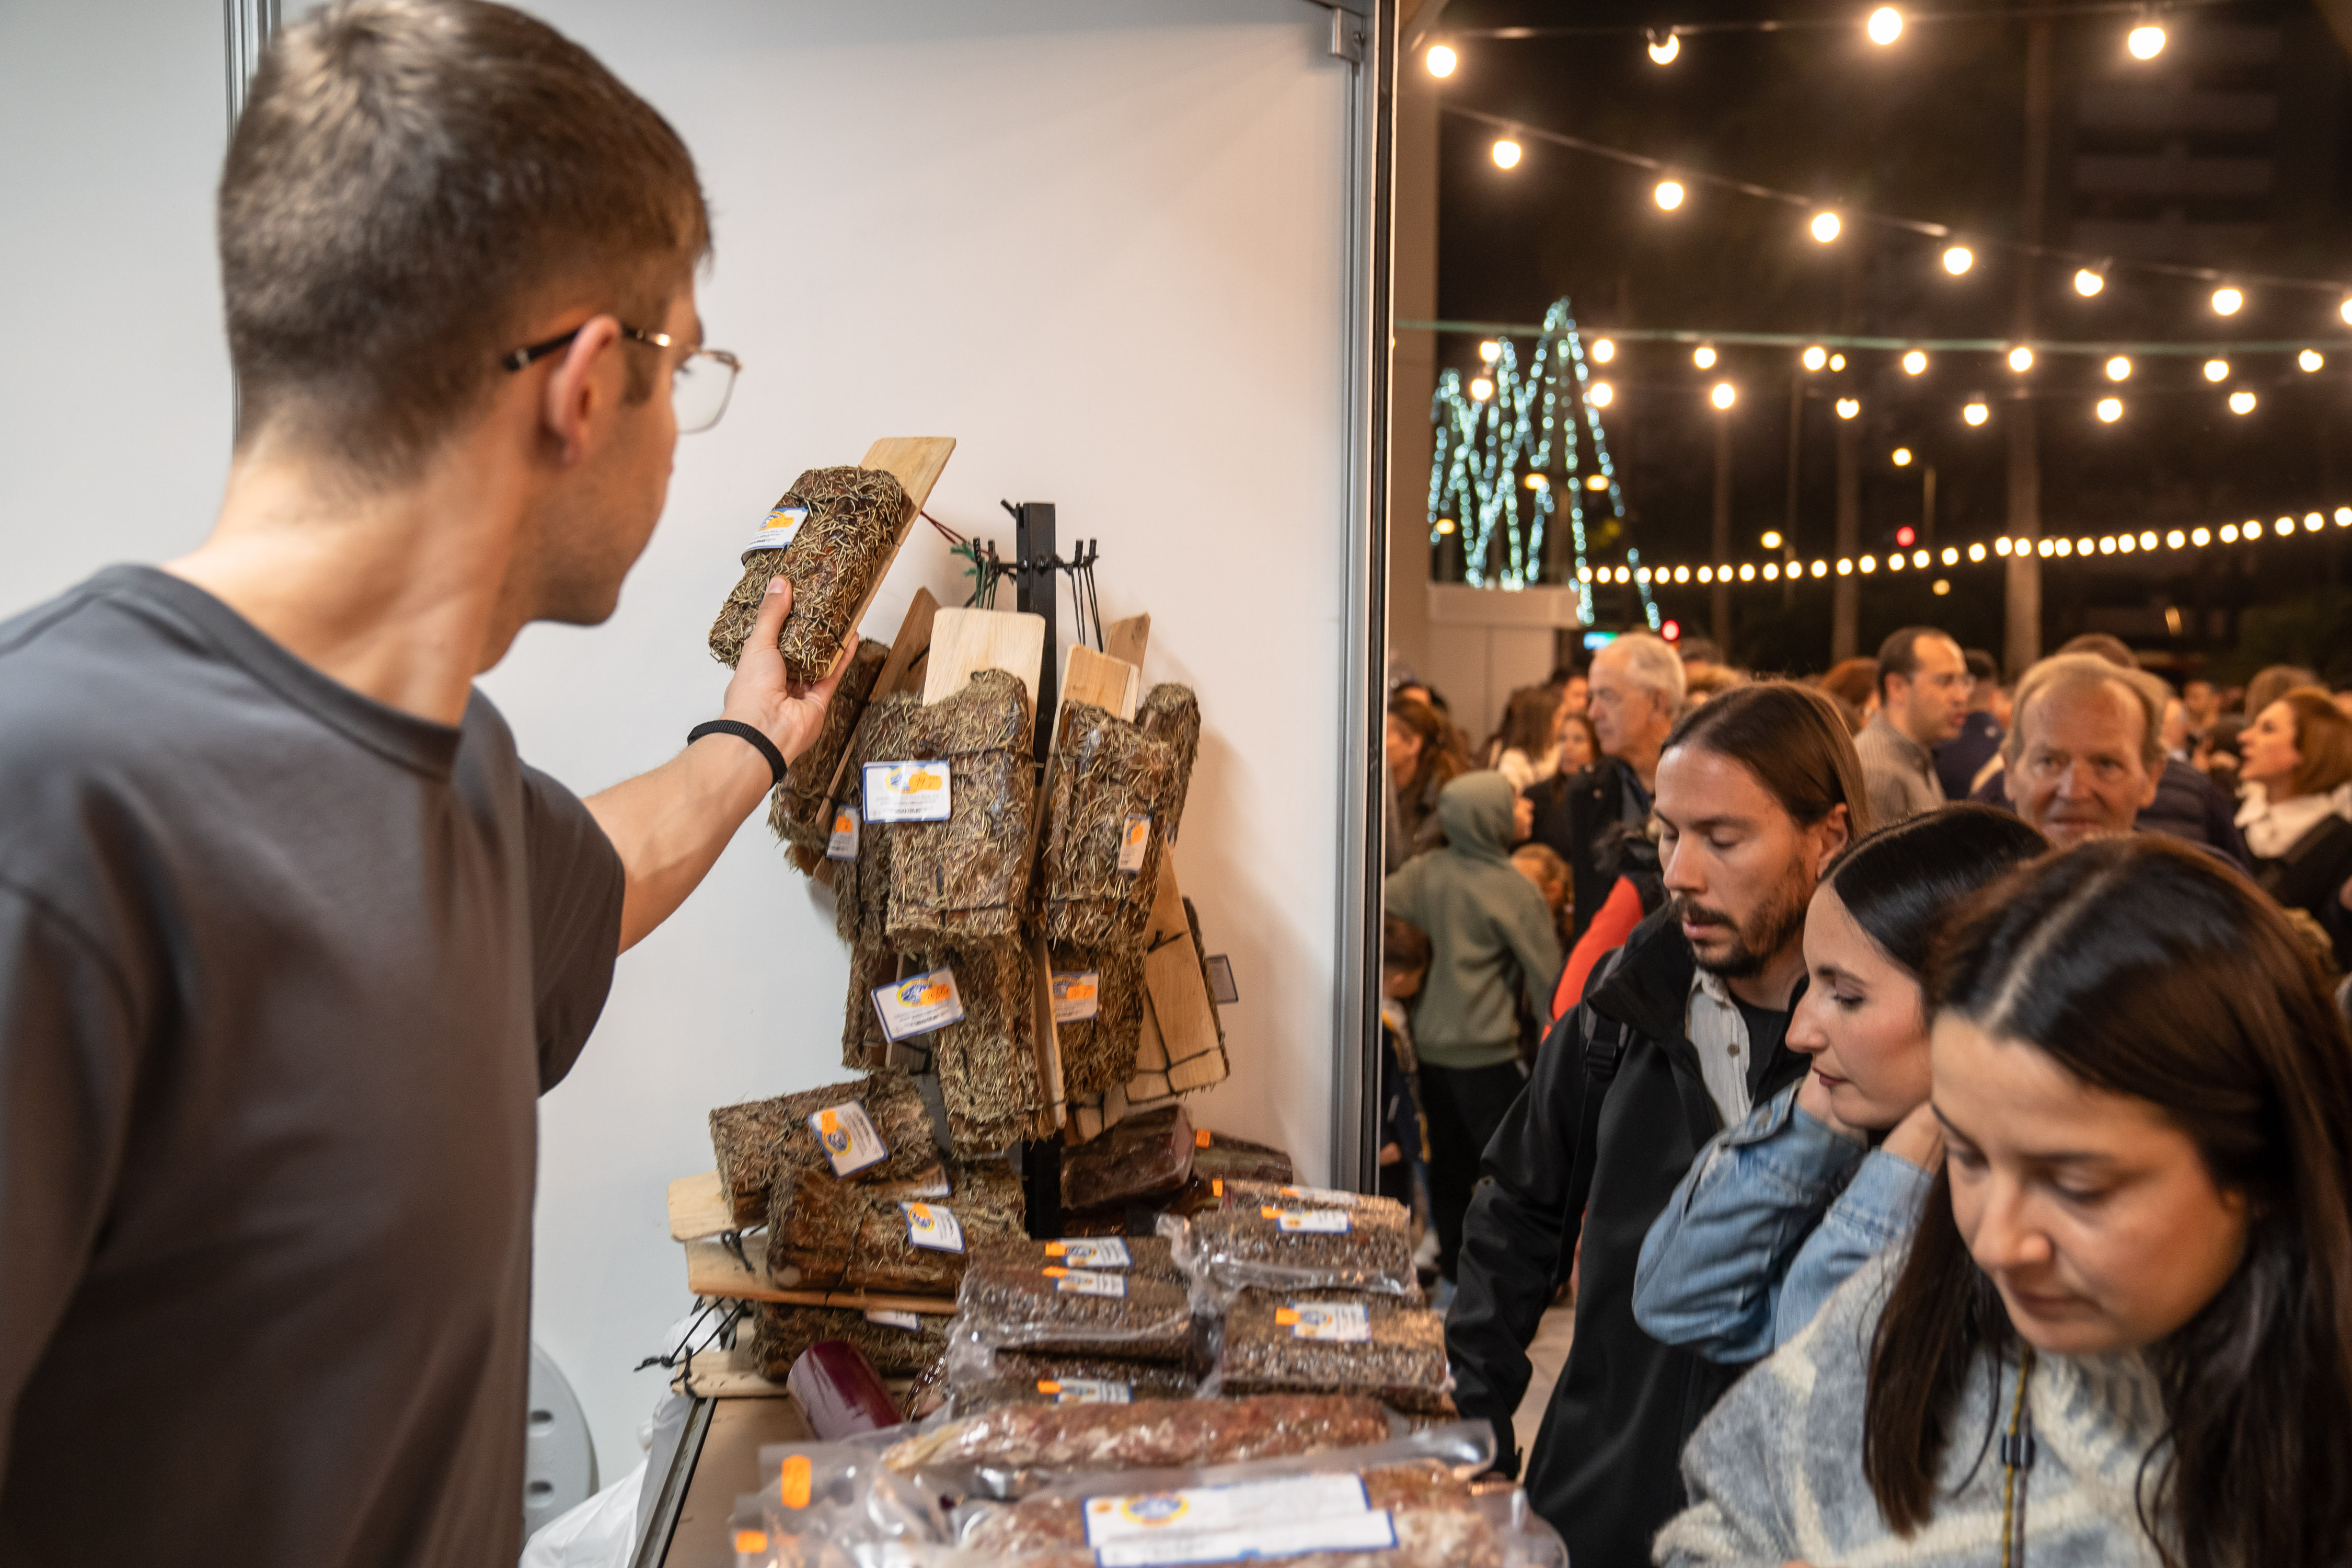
[219,0,710,480]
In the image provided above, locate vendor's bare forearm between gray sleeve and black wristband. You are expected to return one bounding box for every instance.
[586,736,771,952]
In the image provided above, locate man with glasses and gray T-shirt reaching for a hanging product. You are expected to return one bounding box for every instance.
[0,0,833,1568]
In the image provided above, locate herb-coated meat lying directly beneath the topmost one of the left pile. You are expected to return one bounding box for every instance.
[767,1161,1023,1295]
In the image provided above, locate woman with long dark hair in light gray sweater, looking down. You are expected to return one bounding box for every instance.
[1656,835,2352,1568]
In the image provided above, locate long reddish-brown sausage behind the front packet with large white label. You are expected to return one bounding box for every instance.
[882,1397,1390,1474]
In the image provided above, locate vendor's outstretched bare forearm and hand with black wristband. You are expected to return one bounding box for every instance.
[588,576,847,952]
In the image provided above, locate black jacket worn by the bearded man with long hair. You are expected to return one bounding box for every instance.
[1447,910,1804,1568]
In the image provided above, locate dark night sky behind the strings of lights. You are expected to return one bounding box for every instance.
[1404,0,2352,670]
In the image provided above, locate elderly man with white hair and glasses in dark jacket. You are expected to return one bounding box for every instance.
[1529,632,1684,936]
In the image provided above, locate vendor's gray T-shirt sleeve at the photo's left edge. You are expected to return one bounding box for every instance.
[0,882,139,1469]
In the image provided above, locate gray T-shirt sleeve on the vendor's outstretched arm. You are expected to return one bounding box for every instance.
[522,766,628,1093]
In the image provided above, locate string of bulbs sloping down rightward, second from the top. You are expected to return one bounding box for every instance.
[1444,103,2352,310]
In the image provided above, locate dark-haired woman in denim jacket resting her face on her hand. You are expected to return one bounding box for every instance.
[1632,806,2049,1361]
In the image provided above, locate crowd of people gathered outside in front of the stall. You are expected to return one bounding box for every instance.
[1383,628,2352,1568]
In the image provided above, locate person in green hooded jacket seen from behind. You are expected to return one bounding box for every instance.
[1386,774,1560,1279]
